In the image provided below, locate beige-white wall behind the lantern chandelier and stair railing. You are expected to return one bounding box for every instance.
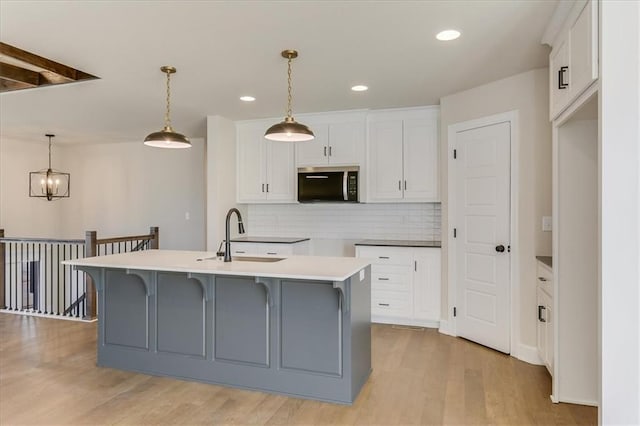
[0,140,205,250]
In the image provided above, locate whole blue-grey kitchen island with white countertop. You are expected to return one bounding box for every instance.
[64,250,371,404]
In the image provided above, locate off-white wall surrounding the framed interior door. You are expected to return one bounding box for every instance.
[440,68,551,356]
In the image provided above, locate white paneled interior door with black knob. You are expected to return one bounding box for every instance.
[453,122,511,353]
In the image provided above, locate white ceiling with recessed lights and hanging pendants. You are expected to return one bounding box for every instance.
[0,0,557,143]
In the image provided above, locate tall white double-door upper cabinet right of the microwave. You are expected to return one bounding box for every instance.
[367,107,439,202]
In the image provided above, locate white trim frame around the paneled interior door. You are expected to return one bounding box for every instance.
[445,110,520,358]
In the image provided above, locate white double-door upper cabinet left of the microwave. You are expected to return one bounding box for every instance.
[236,120,296,203]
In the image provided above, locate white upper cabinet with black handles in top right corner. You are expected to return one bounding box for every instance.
[549,0,598,120]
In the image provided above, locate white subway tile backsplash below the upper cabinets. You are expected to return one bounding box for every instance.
[246,203,440,241]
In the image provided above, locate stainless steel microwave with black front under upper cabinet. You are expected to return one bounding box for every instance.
[298,166,360,203]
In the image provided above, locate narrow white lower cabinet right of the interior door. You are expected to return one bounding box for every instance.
[536,262,554,375]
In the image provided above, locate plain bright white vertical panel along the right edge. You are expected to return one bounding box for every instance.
[599,1,640,425]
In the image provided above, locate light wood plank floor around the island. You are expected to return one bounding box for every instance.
[0,314,597,425]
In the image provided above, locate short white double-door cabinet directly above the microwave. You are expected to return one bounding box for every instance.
[296,112,365,167]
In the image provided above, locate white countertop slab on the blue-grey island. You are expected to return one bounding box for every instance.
[62,250,370,281]
